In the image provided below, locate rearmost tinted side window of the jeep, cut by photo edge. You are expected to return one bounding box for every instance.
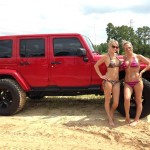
[0,40,13,58]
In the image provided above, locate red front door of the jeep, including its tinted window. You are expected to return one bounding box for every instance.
[50,36,91,87]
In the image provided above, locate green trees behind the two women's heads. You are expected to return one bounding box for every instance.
[94,23,150,57]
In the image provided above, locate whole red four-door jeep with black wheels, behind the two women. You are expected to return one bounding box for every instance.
[0,33,150,117]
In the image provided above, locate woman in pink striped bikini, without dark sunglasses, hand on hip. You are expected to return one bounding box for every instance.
[122,41,150,126]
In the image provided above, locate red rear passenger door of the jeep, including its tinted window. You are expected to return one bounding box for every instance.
[17,36,48,87]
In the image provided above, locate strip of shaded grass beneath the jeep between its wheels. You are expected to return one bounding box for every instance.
[28,94,104,108]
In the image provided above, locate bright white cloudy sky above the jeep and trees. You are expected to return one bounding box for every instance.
[0,0,150,44]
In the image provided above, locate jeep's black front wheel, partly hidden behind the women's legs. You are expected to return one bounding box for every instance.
[117,79,150,118]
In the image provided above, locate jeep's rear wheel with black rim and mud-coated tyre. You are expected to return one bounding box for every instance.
[0,79,26,116]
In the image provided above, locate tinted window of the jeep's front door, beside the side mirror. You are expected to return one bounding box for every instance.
[53,38,83,57]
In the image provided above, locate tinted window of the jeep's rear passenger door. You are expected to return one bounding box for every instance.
[20,39,45,57]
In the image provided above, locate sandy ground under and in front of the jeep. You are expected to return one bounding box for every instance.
[0,95,150,150]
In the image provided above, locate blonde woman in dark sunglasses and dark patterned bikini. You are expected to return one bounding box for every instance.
[94,39,121,126]
